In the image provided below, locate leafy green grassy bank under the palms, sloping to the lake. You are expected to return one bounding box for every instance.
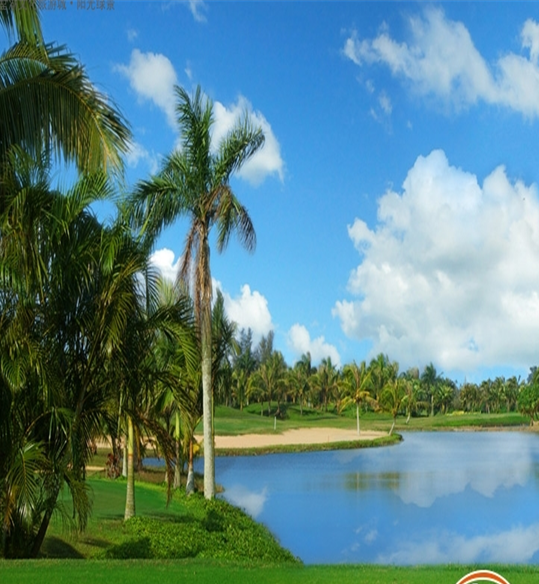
[41,478,297,564]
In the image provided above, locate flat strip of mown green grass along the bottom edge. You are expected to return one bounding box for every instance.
[0,560,539,584]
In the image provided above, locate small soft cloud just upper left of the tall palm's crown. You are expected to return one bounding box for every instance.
[115,49,178,129]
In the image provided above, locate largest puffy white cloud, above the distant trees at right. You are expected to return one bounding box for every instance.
[333,150,539,372]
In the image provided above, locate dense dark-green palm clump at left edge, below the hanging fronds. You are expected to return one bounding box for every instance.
[0,156,130,557]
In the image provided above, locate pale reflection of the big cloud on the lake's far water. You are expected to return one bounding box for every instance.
[335,433,535,507]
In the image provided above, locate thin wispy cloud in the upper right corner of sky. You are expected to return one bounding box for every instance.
[343,7,539,117]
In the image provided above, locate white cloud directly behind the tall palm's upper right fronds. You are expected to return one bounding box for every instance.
[212,96,284,185]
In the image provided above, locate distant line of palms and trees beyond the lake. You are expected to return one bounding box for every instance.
[216,330,539,427]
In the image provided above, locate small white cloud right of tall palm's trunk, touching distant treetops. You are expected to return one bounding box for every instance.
[218,281,273,344]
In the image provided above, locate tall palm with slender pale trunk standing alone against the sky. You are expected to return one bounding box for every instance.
[133,87,264,499]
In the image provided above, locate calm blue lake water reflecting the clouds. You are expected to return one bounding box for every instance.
[196,432,539,564]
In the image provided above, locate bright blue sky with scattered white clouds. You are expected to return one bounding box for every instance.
[31,0,539,382]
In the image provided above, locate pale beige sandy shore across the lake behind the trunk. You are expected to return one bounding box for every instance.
[205,428,387,448]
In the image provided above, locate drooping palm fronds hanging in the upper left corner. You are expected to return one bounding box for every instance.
[0,0,131,172]
